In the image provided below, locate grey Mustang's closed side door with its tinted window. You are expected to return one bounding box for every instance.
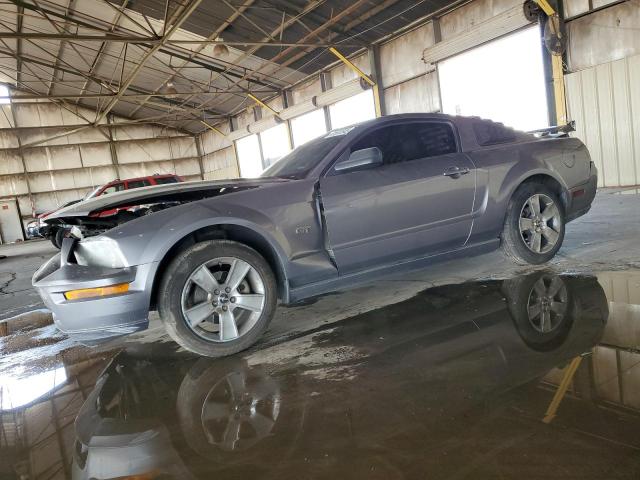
[320,120,476,274]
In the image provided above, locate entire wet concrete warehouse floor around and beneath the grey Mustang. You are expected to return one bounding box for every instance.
[0,190,640,479]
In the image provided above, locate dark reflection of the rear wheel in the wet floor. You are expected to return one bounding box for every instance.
[502,272,575,352]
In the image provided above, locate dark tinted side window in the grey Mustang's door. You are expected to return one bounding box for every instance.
[351,122,457,165]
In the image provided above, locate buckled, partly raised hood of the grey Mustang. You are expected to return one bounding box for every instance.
[47,178,288,220]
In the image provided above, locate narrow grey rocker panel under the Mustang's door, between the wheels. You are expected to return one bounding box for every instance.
[289,238,500,303]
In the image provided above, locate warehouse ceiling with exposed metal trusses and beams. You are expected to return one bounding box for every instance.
[0,0,460,133]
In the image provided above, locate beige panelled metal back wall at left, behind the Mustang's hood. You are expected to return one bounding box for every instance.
[0,103,201,221]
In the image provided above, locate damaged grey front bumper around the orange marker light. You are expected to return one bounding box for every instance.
[33,238,156,342]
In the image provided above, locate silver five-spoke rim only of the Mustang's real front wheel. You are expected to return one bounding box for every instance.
[181,257,266,342]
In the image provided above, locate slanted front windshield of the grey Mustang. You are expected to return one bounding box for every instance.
[261,127,353,178]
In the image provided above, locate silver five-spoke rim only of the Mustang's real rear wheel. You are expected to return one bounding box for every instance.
[519,193,562,253]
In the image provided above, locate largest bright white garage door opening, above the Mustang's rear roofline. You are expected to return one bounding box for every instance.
[438,27,549,131]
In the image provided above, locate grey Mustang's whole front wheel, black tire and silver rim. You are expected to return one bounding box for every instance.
[158,240,277,357]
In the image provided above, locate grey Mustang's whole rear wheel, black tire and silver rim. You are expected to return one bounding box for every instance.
[501,182,566,265]
